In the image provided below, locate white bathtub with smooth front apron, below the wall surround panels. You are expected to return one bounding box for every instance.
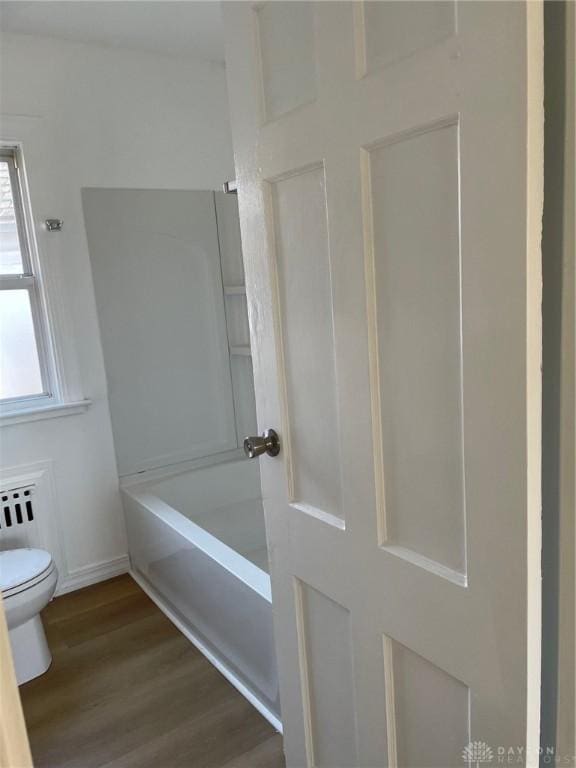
[122,459,281,730]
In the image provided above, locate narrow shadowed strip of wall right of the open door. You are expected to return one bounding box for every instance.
[542,2,576,764]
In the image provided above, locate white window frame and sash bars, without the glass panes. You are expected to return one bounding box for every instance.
[0,142,62,417]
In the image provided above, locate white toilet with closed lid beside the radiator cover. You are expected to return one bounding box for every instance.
[0,548,58,685]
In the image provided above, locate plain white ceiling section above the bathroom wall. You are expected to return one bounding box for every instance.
[0,0,224,63]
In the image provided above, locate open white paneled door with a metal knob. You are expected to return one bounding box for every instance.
[224,1,543,768]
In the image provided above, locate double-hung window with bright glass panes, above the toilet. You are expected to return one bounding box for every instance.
[0,147,54,411]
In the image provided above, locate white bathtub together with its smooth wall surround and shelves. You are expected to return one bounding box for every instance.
[83,189,274,729]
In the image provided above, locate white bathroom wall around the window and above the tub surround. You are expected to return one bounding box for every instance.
[0,35,234,586]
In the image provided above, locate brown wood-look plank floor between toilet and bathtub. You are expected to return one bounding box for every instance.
[20,576,284,768]
